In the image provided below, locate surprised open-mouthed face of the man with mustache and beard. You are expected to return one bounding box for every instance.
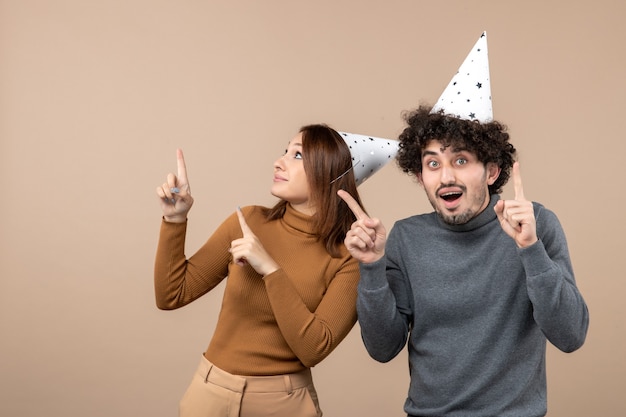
[417,140,500,224]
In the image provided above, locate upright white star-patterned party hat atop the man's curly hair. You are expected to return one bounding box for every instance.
[431,32,493,123]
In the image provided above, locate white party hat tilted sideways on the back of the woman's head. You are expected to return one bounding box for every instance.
[338,132,399,186]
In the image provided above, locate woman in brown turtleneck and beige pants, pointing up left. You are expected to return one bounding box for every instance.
[154,125,360,417]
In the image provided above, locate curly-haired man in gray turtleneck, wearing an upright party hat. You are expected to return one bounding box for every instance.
[339,34,589,417]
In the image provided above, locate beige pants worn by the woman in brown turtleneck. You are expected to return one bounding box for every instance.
[179,355,322,417]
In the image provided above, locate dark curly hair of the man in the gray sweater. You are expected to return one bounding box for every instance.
[396,105,516,194]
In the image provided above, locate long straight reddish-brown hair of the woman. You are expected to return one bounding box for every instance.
[267,124,363,257]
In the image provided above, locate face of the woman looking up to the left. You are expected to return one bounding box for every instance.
[271,133,315,215]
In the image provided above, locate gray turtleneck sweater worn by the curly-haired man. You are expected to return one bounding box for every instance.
[357,195,589,417]
